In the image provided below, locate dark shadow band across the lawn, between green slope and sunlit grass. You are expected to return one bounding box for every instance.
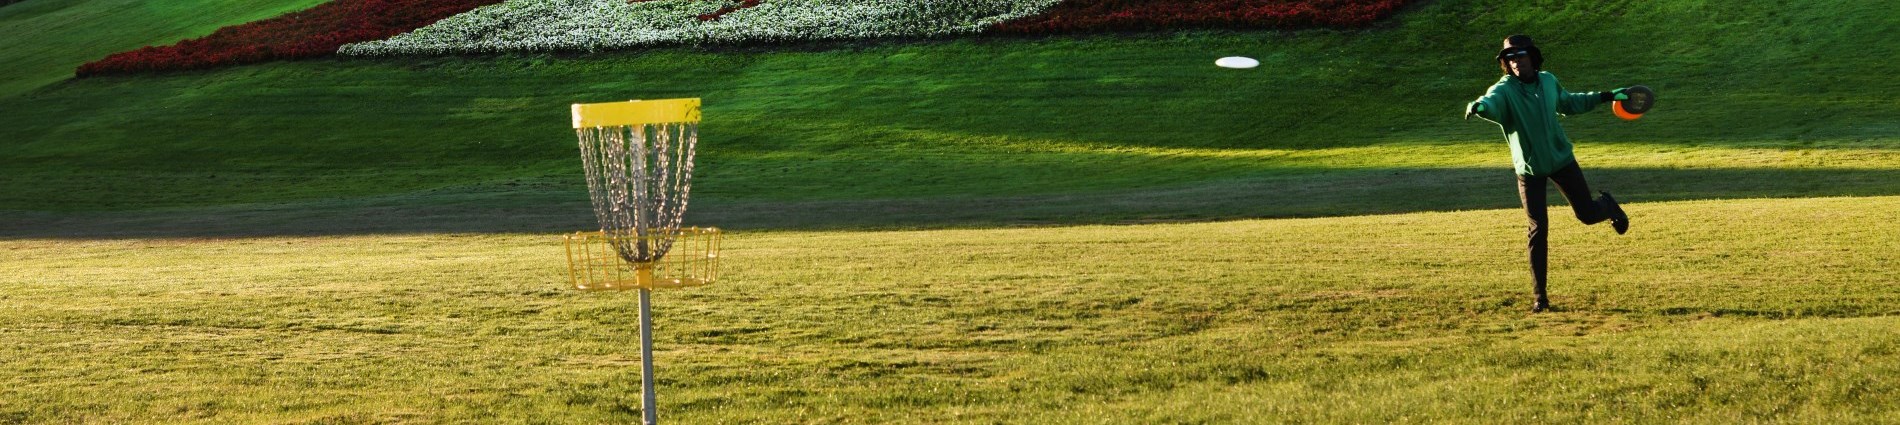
[0,169,1900,239]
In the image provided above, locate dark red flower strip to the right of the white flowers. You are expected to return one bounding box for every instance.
[996,0,1408,34]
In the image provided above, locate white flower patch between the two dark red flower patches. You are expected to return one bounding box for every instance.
[338,0,1060,57]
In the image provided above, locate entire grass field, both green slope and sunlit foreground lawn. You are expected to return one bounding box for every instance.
[0,0,1900,423]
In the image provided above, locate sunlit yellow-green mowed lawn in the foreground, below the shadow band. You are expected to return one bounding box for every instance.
[0,197,1900,423]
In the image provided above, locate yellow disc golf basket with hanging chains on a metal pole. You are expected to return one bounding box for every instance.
[566,99,720,425]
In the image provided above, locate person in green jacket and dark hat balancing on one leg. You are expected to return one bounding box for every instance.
[1465,34,1630,313]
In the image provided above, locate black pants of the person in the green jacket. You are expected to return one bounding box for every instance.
[1518,163,1609,300]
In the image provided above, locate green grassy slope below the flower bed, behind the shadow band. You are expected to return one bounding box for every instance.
[0,0,1900,226]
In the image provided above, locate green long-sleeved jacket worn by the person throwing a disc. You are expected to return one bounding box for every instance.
[1478,72,1604,176]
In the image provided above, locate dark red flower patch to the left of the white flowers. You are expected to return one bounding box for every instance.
[74,0,502,78]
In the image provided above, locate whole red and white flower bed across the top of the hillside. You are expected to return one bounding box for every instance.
[77,0,1410,69]
